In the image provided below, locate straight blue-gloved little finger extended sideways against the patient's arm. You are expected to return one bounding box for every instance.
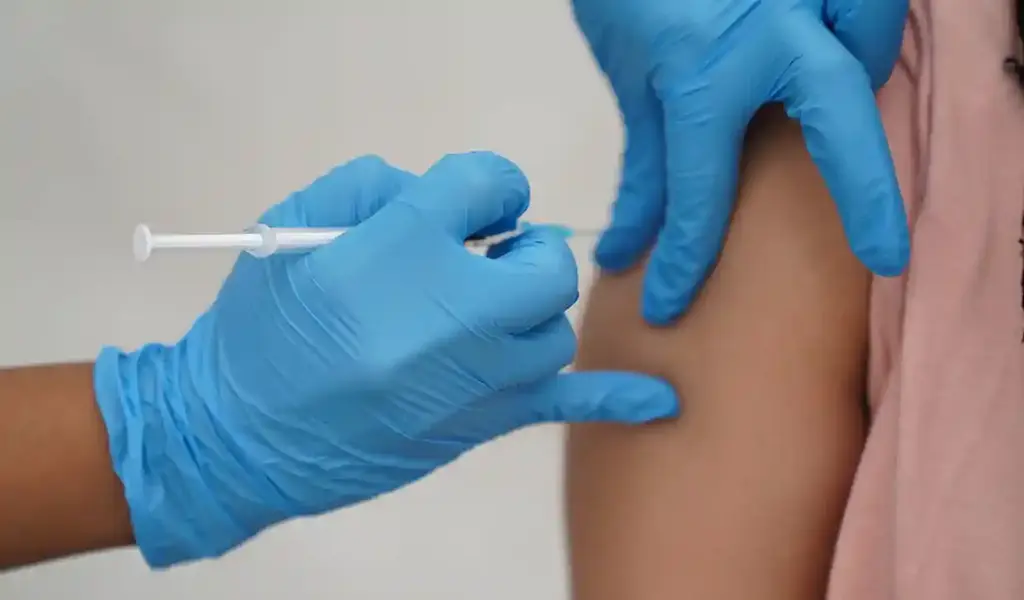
[511,372,679,425]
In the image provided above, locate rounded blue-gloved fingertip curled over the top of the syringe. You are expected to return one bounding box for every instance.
[389,152,529,244]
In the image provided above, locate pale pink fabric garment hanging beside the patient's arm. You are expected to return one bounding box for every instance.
[828,0,1024,600]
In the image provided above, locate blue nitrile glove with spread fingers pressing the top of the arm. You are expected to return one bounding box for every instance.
[572,0,909,324]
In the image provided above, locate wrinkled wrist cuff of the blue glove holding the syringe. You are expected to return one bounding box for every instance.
[93,344,251,568]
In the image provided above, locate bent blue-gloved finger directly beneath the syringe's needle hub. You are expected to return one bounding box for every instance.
[474,227,580,334]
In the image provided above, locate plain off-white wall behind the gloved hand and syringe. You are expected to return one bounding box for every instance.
[0,0,620,600]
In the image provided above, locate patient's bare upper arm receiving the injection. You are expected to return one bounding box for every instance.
[567,110,869,600]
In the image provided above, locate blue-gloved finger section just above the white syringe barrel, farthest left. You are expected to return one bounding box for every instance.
[260,156,416,227]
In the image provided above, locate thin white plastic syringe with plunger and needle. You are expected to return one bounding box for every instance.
[132,223,598,262]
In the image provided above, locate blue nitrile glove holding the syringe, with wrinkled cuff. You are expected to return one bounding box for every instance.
[95,153,678,566]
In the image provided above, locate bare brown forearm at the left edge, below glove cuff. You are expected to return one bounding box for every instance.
[0,363,133,569]
